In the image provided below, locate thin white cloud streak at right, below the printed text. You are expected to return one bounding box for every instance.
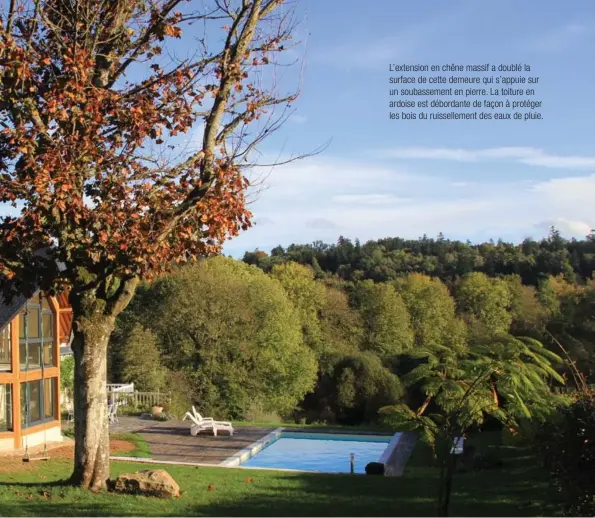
[378,147,595,170]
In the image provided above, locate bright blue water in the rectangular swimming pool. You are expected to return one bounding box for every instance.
[242,432,392,473]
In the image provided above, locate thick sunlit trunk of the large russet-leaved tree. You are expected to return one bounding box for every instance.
[70,280,136,491]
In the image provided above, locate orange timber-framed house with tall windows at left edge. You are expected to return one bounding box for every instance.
[0,292,72,452]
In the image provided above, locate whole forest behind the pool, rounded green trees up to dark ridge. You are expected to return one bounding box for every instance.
[109,229,595,425]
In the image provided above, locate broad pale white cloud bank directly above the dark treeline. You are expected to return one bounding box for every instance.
[228,158,595,256]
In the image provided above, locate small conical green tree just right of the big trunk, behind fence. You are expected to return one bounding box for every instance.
[122,324,167,392]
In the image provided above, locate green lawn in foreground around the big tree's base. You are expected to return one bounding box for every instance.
[0,434,551,516]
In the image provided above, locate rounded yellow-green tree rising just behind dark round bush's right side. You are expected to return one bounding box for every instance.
[354,281,413,357]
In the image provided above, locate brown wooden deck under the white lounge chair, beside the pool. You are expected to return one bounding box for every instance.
[140,421,274,465]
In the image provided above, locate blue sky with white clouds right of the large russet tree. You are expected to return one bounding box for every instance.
[224,0,595,257]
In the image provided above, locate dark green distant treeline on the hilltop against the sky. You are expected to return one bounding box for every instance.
[243,227,595,286]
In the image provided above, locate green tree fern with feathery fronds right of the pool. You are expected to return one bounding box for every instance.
[380,334,563,516]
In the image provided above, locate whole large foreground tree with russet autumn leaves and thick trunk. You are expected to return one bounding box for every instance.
[0,0,302,490]
